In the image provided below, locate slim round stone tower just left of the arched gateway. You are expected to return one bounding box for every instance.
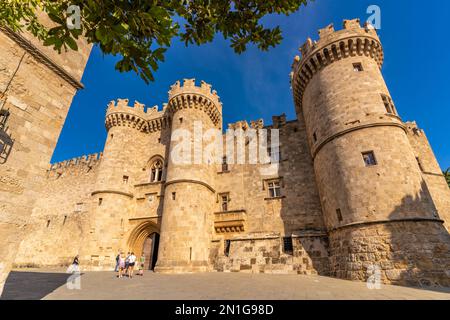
[85,99,158,269]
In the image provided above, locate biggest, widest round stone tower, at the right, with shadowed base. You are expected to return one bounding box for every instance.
[291,20,450,284]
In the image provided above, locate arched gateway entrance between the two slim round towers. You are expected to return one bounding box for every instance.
[128,221,159,270]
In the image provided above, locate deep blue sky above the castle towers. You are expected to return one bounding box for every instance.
[52,0,450,168]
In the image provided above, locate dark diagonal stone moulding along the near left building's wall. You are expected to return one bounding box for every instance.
[0,27,84,90]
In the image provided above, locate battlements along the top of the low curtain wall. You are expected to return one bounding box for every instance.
[47,152,103,178]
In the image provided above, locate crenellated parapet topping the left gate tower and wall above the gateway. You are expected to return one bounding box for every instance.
[105,99,169,132]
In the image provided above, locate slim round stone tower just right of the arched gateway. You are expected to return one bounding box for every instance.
[155,79,222,273]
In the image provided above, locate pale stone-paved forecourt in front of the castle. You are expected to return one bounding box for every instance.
[1,269,450,300]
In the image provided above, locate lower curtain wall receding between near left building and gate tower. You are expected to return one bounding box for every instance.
[15,154,101,267]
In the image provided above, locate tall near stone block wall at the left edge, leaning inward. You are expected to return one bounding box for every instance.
[0,29,91,291]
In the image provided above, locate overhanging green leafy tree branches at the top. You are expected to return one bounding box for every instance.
[0,0,308,83]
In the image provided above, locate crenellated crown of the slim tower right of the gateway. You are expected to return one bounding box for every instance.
[168,79,222,126]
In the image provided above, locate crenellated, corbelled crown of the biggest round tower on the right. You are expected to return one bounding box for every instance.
[290,19,384,112]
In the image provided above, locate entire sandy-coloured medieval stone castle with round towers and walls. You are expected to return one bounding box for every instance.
[0,20,450,286]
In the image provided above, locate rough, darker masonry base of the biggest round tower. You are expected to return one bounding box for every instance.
[330,221,450,287]
